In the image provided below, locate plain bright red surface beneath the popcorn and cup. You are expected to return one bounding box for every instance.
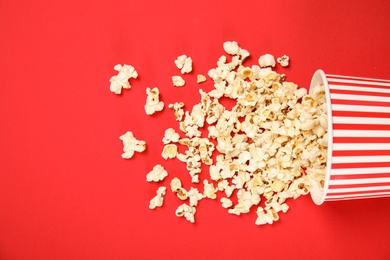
[0,0,390,259]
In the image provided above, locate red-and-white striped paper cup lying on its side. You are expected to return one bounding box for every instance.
[310,70,390,205]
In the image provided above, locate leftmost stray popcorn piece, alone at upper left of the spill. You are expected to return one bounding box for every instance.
[110,64,138,94]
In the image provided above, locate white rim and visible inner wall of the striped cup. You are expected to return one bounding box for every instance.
[308,70,333,205]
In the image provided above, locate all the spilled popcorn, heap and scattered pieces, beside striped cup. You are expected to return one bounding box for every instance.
[110,41,328,225]
